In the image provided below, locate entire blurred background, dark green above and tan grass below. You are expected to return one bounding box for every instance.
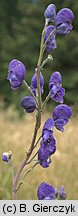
[0,0,78,199]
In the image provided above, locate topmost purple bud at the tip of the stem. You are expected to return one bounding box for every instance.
[44,4,56,22]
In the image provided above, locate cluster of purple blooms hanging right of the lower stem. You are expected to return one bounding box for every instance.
[38,104,72,168]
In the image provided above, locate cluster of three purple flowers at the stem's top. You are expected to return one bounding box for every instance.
[44,4,74,52]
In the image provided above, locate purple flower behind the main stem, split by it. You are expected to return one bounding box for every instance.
[31,72,44,95]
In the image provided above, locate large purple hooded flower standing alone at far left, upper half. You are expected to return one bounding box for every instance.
[7,59,26,90]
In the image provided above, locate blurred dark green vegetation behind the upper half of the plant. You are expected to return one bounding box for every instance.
[0,0,78,110]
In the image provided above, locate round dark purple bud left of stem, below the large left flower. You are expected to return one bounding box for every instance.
[20,96,36,113]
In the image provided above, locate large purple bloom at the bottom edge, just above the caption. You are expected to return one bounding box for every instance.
[37,182,56,200]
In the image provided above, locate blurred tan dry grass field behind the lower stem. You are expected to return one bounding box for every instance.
[0,109,78,200]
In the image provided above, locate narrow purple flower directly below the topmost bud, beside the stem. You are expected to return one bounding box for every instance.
[44,25,57,52]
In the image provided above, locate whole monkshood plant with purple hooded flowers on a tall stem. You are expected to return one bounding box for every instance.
[2,4,74,200]
